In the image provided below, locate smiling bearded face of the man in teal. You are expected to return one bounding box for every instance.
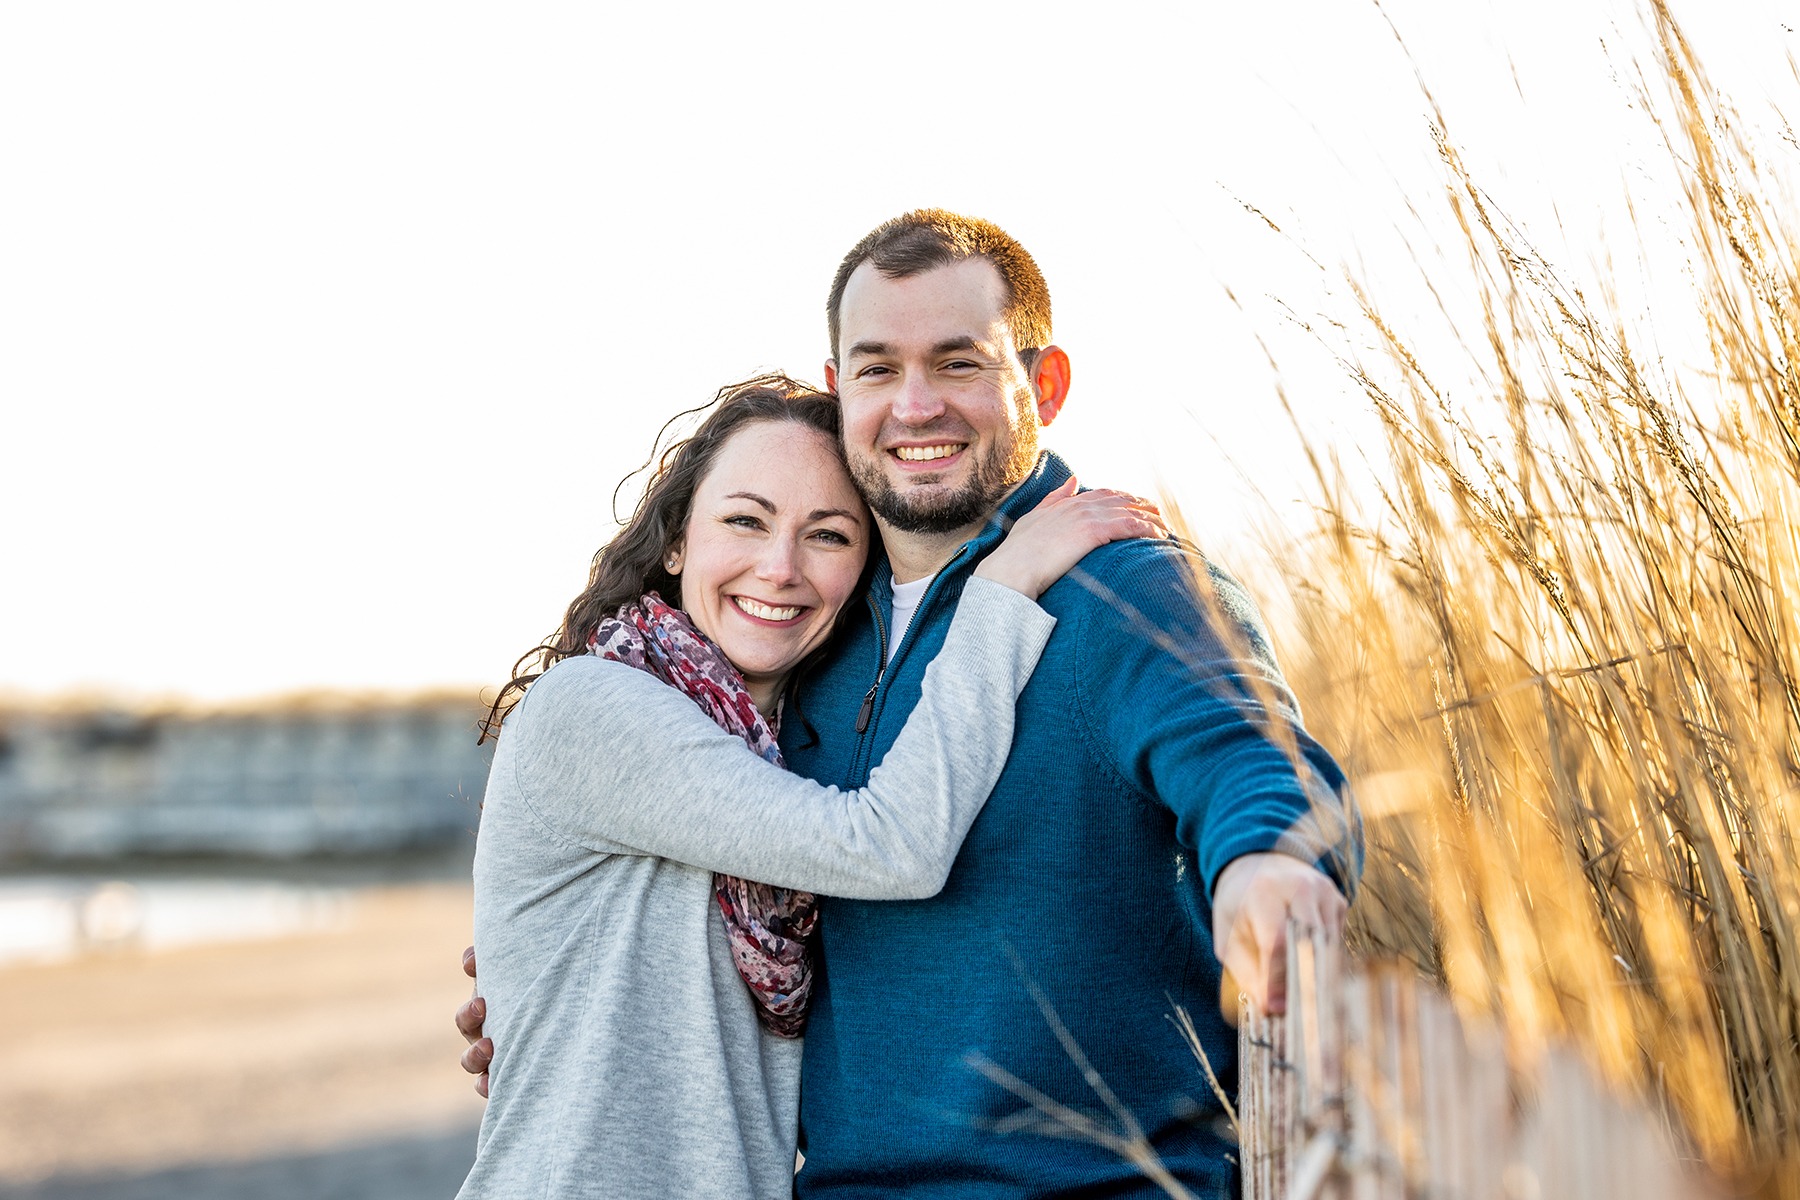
[826,257,1039,533]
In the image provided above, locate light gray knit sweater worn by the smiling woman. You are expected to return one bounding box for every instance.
[459,579,1055,1200]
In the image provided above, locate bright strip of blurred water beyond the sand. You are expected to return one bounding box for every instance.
[0,874,355,966]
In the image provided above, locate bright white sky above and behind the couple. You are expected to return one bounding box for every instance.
[0,0,1800,698]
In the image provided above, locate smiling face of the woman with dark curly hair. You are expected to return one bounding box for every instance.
[673,421,869,712]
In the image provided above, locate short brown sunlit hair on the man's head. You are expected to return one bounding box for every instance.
[824,209,1049,367]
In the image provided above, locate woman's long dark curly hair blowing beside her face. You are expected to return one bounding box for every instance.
[481,374,856,741]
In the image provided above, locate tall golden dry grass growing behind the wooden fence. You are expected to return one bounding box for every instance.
[1260,0,1800,1195]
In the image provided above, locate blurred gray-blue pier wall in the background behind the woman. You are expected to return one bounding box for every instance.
[0,696,491,865]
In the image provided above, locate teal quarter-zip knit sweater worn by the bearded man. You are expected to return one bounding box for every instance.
[783,453,1354,1200]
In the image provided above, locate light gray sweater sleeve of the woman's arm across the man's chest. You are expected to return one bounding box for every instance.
[502,579,1055,900]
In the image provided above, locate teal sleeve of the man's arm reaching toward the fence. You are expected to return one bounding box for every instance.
[1058,540,1361,896]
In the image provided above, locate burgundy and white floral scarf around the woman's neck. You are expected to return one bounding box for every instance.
[587,592,819,1038]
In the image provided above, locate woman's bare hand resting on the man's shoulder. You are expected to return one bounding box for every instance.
[976,479,1168,599]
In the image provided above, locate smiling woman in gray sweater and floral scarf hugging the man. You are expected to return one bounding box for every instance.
[461,376,1161,1198]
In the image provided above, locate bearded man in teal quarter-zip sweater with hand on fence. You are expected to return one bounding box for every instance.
[459,210,1348,1196]
